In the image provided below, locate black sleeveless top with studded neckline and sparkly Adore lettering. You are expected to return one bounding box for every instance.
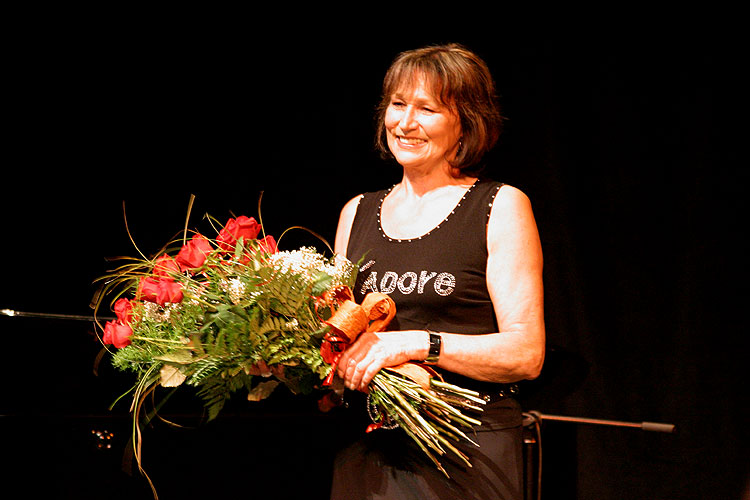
[347,179,516,398]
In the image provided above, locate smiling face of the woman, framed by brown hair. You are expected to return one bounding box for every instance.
[385,78,461,174]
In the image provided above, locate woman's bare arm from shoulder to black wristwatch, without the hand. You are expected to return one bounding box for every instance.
[439,186,545,382]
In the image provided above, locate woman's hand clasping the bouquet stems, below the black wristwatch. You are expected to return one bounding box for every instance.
[337,331,429,392]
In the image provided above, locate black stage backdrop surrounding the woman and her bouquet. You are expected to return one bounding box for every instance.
[0,16,748,499]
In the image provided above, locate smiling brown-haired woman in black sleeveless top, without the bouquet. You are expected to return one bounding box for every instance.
[332,45,544,499]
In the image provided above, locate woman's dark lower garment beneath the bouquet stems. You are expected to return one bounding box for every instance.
[331,398,523,500]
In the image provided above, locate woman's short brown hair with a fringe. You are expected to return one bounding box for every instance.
[375,44,503,173]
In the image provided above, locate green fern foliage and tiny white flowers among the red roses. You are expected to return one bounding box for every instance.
[106,240,354,419]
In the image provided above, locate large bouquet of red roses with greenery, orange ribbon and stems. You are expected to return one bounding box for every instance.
[99,207,484,492]
